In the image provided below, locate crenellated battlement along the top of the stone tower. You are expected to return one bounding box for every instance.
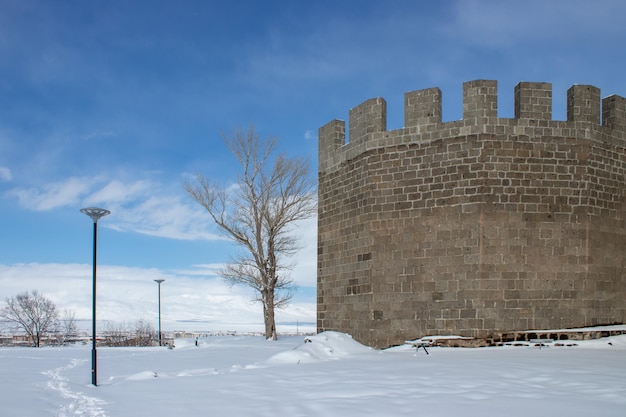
[319,80,626,172]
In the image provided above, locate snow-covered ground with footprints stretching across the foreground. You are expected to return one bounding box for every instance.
[0,332,626,417]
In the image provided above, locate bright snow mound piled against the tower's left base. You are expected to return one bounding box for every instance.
[266,331,374,365]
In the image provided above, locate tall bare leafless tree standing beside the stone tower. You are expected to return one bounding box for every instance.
[184,126,316,340]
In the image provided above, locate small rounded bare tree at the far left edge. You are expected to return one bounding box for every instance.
[0,291,59,347]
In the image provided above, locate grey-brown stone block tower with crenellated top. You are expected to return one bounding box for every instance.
[317,80,626,348]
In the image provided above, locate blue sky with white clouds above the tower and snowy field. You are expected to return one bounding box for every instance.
[0,0,626,330]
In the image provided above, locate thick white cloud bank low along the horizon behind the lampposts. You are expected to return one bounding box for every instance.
[0,263,315,330]
